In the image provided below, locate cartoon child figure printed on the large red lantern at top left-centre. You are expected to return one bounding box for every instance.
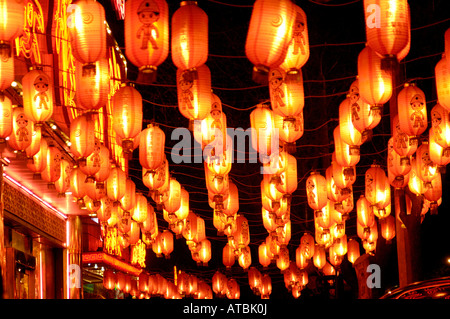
[137,0,160,50]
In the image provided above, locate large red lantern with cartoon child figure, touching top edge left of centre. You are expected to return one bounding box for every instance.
[124,0,169,77]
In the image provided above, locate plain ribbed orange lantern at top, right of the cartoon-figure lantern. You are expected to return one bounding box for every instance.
[171,1,208,70]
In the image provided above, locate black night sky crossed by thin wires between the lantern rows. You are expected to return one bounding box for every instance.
[100,0,450,299]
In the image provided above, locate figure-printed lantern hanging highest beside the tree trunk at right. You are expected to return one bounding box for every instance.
[398,83,428,138]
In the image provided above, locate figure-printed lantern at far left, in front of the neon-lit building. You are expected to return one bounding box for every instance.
[22,69,53,124]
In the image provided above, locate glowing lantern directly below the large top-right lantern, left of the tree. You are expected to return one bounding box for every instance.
[358,46,392,109]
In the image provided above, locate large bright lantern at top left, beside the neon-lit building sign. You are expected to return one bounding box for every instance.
[68,0,106,67]
